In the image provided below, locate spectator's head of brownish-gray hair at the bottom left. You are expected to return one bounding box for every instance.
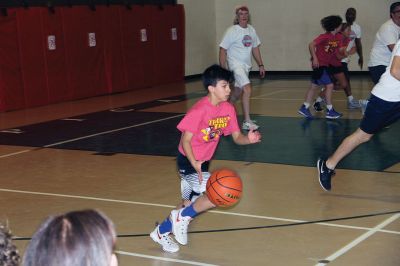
[23,210,116,266]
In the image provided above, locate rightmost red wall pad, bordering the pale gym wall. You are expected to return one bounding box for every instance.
[153,5,185,84]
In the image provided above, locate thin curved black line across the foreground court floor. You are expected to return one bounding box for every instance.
[13,210,400,240]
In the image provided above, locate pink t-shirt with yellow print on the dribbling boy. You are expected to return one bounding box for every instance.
[177,96,240,161]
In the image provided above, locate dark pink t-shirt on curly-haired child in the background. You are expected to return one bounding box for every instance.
[314,32,342,66]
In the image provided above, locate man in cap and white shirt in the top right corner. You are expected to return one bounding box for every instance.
[368,2,400,84]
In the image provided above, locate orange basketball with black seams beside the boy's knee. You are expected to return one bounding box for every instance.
[206,168,243,207]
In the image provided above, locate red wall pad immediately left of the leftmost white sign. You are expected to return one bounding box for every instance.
[17,7,49,107]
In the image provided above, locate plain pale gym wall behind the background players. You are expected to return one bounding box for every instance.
[178,0,395,75]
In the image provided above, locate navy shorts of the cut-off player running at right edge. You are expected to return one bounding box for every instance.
[360,95,400,134]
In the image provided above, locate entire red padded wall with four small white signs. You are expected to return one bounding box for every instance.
[0,5,185,111]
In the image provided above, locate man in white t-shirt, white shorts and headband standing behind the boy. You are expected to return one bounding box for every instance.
[219,6,265,130]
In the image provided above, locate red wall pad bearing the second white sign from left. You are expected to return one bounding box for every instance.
[62,6,108,99]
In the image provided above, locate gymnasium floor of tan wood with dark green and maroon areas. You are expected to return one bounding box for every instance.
[0,77,400,266]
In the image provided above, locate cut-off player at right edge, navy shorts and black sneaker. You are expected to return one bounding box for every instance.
[317,41,400,191]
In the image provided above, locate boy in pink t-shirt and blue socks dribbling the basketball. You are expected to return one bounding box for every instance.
[150,65,261,252]
